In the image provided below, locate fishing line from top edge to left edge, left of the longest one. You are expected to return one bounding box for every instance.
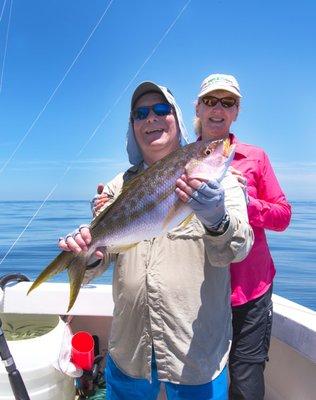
[0,0,114,174]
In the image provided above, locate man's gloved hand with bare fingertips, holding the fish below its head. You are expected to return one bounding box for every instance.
[176,175,226,230]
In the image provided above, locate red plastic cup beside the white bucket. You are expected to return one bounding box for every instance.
[71,331,94,371]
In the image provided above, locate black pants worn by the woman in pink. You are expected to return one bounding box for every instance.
[229,286,272,400]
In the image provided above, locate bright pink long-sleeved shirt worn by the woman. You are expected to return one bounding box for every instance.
[230,134,291,306]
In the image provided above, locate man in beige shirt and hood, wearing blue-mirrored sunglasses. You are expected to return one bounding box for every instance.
[59,82,253,400]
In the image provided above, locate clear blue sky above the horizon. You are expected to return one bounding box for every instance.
[0,0,316,200]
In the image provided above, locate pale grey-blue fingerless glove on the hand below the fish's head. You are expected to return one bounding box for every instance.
[188,179,226,230]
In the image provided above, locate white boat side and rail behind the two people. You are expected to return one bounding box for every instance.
[0,282,316,400]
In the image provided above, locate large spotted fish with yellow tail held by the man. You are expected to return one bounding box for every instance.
[28,139,234,312]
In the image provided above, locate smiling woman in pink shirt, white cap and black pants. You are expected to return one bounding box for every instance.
[195,74,291,400]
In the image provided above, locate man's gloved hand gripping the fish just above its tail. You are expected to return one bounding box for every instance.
[58,225,103,258]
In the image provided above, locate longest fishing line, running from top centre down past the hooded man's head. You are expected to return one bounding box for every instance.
[0,0,192,265]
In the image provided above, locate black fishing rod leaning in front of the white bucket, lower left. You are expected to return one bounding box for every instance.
[0,318,30,400]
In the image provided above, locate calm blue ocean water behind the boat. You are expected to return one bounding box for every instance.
[0,201,316,310]
